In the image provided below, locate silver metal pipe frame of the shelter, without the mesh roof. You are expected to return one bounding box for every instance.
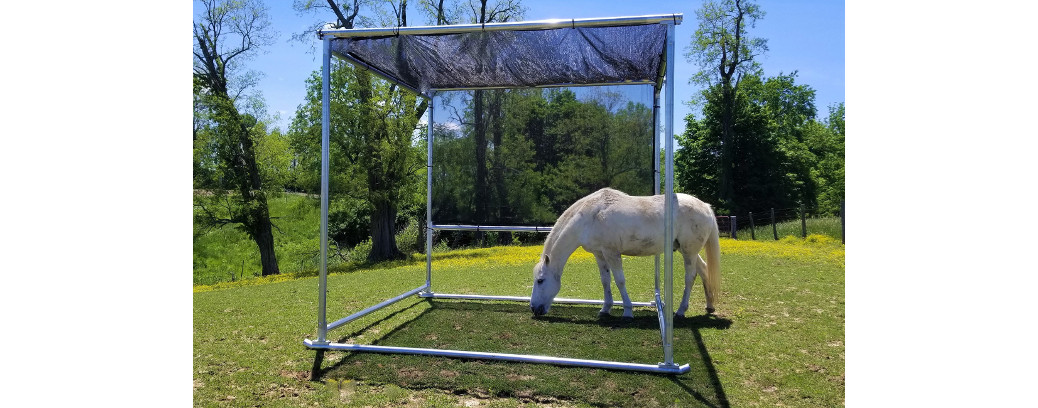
[303,19,690,374]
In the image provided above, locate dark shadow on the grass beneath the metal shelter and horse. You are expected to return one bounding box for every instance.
[310,299,732,407]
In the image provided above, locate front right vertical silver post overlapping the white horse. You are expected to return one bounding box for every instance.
[663,23,678,365]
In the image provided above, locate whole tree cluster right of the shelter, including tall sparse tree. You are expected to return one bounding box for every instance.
[675,0,844,218]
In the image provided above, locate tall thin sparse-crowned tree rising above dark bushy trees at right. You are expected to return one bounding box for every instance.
[685,0,768,206]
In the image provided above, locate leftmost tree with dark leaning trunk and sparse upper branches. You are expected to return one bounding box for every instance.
[193,0,279,276]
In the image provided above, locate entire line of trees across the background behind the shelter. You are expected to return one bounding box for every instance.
[193,0,844,275]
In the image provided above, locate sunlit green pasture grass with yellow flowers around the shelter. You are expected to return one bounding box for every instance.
[194,237,844,407]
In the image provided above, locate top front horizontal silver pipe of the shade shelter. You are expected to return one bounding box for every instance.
[318,13,684,38]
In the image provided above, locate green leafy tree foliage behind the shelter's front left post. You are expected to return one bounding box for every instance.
[288,61,426,251]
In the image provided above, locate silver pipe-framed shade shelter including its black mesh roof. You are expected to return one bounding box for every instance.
[303,15,690,374]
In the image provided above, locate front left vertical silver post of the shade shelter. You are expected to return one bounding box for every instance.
[318,35,332,344]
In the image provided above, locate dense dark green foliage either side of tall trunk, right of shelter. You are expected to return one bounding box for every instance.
[675,73,843,214]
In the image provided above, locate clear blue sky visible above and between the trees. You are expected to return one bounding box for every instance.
[249,0,845,133]
